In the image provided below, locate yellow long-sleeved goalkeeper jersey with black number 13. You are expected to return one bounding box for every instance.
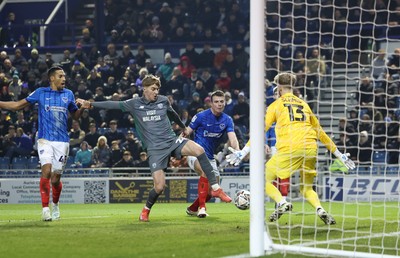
[265,93,336,153]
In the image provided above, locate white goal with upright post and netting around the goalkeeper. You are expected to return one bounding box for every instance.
[250,0,400,258]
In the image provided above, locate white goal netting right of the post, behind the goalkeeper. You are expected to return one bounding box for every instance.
[265,0,400,257]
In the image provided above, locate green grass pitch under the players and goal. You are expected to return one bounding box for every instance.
[0,203,400,258]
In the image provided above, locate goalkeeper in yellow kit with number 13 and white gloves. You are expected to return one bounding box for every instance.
[227,73,355,224]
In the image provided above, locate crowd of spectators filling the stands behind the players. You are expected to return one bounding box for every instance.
[0,0,400,171]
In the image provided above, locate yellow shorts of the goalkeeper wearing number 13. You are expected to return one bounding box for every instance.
[265,149,317,181]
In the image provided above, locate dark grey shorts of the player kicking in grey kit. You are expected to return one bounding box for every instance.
[147,137,188,173]
